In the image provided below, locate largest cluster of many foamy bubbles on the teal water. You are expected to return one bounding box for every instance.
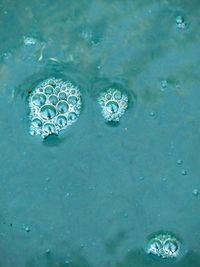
[29,78,81,138]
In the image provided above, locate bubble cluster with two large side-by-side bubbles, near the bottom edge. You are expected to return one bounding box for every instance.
[147,234,180,259]
